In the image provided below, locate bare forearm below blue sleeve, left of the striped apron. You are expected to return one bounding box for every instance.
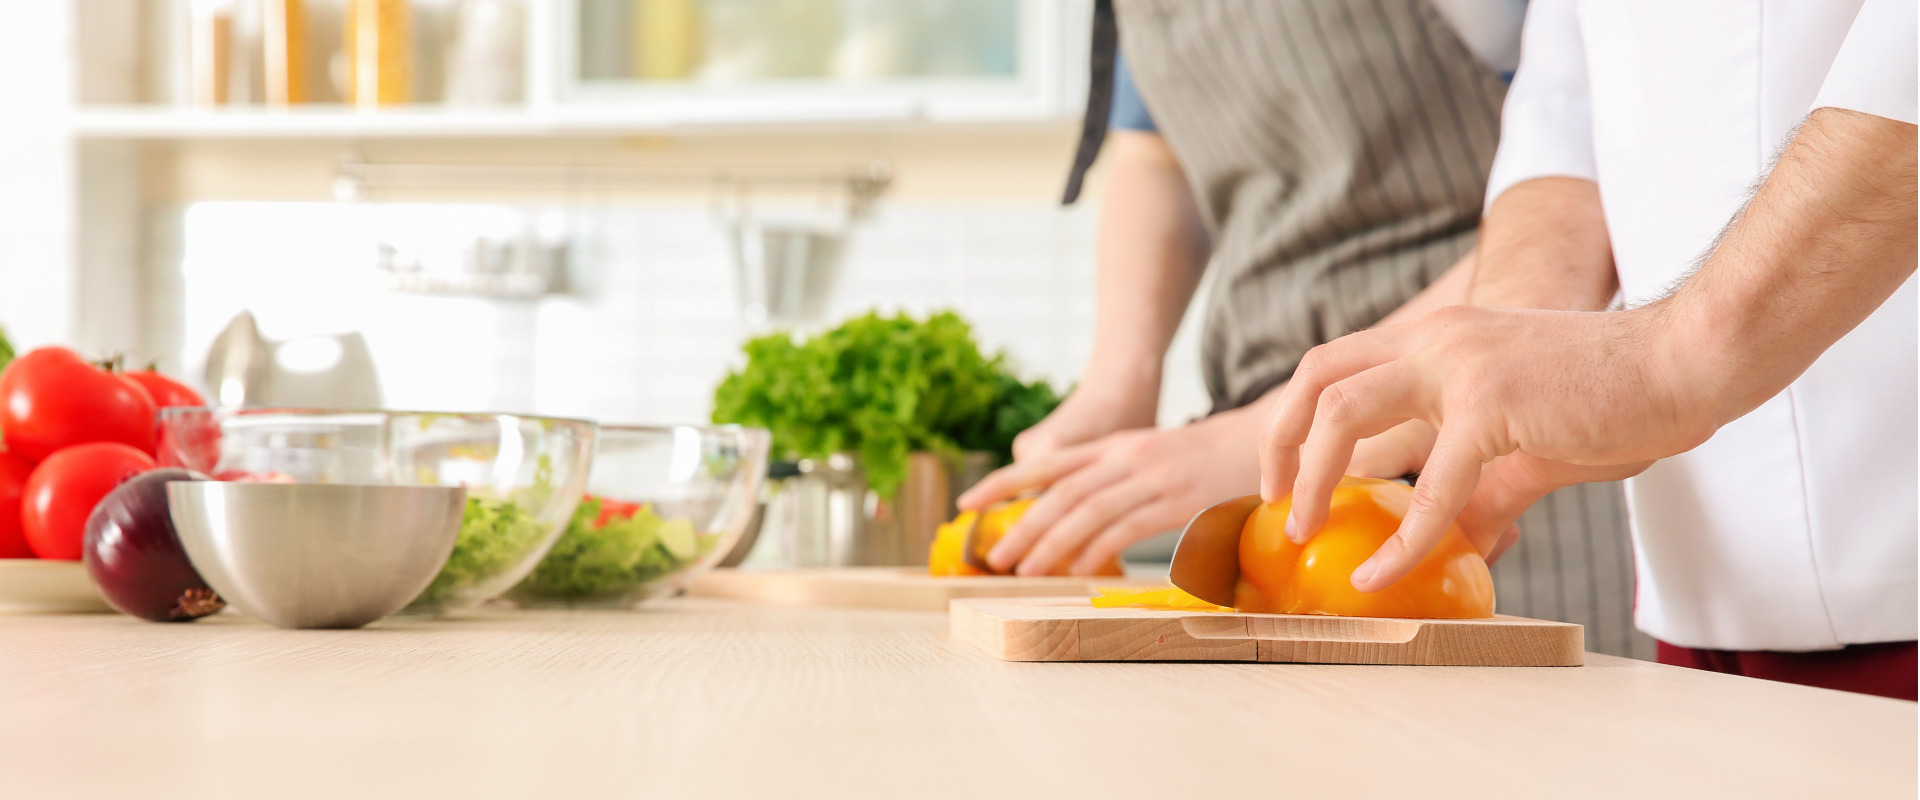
[1083,130,1208,395]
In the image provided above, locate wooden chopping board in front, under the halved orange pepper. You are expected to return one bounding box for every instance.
[948,597,1586,666]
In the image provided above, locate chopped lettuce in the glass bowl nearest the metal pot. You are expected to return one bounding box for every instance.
[515,497,720,600]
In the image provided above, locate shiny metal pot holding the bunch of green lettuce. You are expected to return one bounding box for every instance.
[728,453,998,568]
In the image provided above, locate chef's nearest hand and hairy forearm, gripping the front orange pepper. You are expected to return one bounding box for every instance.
[1261,109,1916,591]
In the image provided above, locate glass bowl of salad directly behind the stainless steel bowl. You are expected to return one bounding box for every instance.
[159,409,595,614]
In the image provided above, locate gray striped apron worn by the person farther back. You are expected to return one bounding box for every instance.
[1069,0,1651,658]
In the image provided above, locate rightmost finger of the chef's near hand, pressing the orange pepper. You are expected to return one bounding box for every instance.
[1354,424,1482,591]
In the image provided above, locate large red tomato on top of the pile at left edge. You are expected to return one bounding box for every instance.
[0,347,157,460]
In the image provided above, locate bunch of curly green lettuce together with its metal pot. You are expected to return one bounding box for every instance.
[712,311,1060,566]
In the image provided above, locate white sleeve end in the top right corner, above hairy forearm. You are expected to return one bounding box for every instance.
[1812,0,1920,123]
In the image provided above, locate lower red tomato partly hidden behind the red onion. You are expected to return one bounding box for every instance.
[19,441,154,560]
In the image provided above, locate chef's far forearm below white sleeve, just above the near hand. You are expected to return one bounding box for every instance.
[1469,178,1619,311]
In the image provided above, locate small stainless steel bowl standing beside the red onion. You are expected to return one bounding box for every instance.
[167,482,467,627]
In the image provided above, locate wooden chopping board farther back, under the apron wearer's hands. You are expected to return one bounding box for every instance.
[687,566,1165,612]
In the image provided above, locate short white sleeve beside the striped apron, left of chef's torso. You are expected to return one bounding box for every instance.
[1486,0,1589,207]
